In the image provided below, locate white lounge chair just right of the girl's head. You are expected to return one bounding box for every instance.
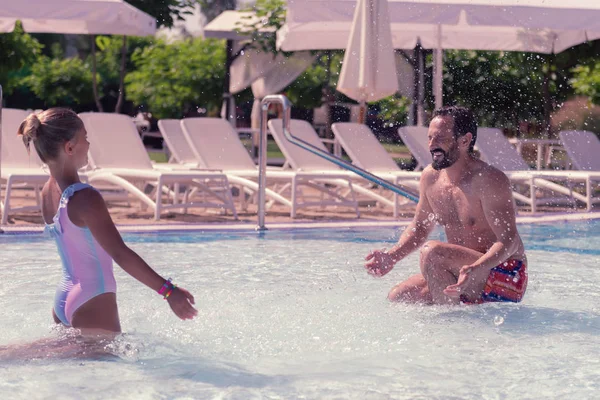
[79,113,237,220]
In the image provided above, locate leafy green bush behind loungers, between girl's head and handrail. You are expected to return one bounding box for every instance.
[125,38,225,118]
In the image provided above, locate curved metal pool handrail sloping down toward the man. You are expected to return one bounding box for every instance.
[257,95,419,230]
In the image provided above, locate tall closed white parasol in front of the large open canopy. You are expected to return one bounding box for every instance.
[337,0,398,123]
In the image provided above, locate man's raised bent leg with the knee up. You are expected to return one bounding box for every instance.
[421,240,489,304]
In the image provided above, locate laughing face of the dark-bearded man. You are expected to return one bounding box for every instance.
[427,116,460,171]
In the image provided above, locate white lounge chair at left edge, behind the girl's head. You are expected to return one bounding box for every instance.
[0,108,49,225]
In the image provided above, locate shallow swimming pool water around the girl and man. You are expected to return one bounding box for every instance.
[0,221,600,399]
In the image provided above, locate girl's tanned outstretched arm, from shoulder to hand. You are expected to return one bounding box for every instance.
[68,189,198,319]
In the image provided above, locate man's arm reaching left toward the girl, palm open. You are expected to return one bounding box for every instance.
[365,167,435,276]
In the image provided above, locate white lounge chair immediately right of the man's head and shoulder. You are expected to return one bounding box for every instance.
[475,128,600,212]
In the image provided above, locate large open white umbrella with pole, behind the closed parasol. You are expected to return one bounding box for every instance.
[277,0,600,109]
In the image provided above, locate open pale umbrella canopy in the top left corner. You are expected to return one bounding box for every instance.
[0,0,156,36]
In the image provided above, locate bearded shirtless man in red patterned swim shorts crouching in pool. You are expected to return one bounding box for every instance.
[365,107,527,304]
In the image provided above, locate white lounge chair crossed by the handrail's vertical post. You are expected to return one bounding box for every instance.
[178,118,359,218]
